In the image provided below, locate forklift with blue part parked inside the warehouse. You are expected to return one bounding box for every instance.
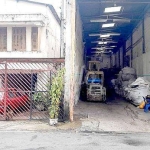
[85,61,106,102]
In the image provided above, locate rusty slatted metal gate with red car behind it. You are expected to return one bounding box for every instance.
[0,59,64,120]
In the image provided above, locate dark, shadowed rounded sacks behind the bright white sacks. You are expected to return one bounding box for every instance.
[115,67,136,97]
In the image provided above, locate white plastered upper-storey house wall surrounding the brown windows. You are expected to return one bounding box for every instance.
[0,0,60,58]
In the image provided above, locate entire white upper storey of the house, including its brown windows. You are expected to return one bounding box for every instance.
[0,0,60,58]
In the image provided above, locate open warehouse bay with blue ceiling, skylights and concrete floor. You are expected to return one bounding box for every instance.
[70,0,150,132]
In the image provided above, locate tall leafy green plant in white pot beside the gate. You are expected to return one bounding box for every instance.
[48,69,65,125]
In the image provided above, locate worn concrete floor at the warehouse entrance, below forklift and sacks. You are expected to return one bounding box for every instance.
[75,98,150,133]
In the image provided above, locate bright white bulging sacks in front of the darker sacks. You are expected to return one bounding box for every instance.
[125,77,150,106]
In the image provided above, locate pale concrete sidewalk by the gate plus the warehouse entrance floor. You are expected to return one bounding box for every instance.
[0,100,150,133]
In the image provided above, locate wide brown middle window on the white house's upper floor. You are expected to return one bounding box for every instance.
[12,27,26,51]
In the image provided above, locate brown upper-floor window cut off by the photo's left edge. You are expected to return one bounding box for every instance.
[0,27,7,51]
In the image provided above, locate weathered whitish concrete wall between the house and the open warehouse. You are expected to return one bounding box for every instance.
[64,0,84,121]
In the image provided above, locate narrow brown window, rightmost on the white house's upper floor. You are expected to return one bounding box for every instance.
[31,27,38,51]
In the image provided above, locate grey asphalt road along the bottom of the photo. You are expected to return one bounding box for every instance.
[0,131,150,150]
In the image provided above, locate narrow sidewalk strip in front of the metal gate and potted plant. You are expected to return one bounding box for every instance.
[0,120,81,131]
